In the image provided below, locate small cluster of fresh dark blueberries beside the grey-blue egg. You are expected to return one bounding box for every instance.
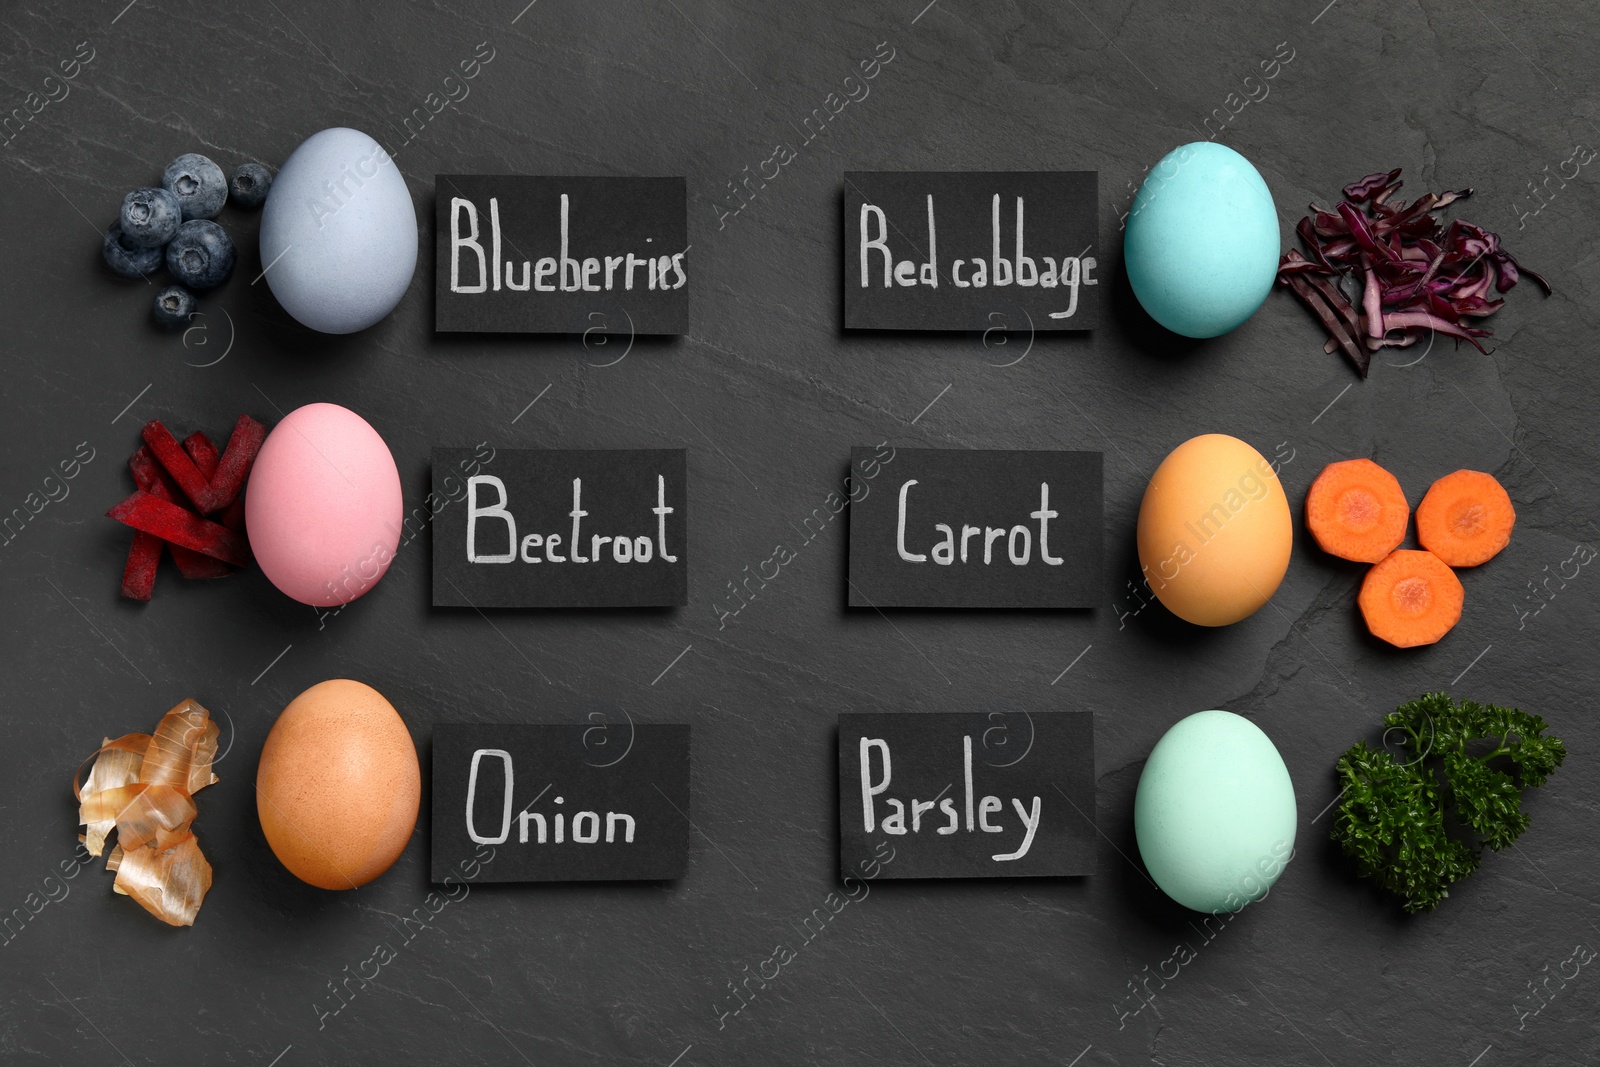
[104,152,272,330]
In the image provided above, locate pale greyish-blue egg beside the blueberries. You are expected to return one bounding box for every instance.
[261,126,418,333]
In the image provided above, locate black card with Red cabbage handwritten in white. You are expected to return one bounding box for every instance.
[845,171,1102,333]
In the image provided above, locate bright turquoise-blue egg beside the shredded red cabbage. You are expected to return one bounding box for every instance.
[1122,141,1282,338]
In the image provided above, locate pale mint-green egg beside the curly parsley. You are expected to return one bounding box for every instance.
[1133,710,1298,913]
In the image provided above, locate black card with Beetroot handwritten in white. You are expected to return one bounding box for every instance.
[434,448,690,608]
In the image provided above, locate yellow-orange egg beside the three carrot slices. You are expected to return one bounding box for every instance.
[1132,434,1294,625]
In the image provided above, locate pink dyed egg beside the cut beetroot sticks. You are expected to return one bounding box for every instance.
[245,403,405,608]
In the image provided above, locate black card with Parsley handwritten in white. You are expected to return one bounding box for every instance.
[838,709,1096,878]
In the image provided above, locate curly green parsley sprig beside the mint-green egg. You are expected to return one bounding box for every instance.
[1333,693,1566,912]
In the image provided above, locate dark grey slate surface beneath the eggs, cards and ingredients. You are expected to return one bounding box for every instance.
[0,0,1600,1067]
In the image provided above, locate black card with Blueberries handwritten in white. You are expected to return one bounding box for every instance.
[434,174,690,336]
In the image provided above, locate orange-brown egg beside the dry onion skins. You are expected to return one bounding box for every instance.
[256,678,422,889]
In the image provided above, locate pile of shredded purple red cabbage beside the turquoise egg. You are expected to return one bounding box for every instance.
[1278,168,1550,378]
